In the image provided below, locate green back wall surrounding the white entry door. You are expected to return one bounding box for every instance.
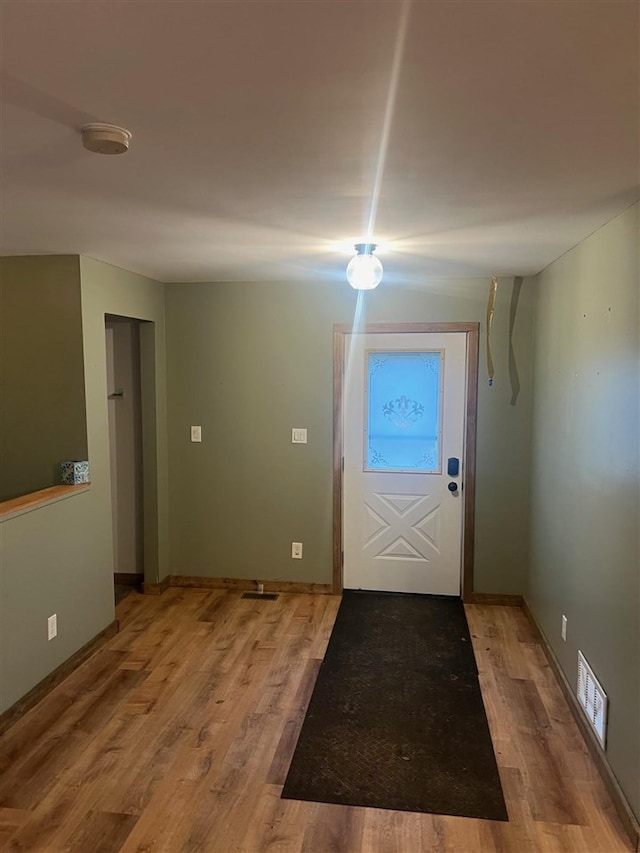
[166,279,532,593]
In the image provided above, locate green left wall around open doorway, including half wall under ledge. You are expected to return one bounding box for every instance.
[0,258,168,711]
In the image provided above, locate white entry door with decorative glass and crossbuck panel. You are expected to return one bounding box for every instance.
[343,332,467,595]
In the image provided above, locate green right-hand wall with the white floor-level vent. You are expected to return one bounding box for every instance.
[527,205,640,817]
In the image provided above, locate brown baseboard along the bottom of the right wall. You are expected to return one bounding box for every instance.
[522,599,640,853]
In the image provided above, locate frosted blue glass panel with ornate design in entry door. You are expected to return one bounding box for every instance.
[364,350,443,474]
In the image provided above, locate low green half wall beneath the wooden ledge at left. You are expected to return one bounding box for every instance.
[0,490,114,713]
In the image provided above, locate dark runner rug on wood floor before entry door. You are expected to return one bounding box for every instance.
[282,590,508,820]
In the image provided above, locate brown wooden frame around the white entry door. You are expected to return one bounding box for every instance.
[333,323,480,601]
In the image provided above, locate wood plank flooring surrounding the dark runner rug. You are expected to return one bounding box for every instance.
[0,588,631,853]
